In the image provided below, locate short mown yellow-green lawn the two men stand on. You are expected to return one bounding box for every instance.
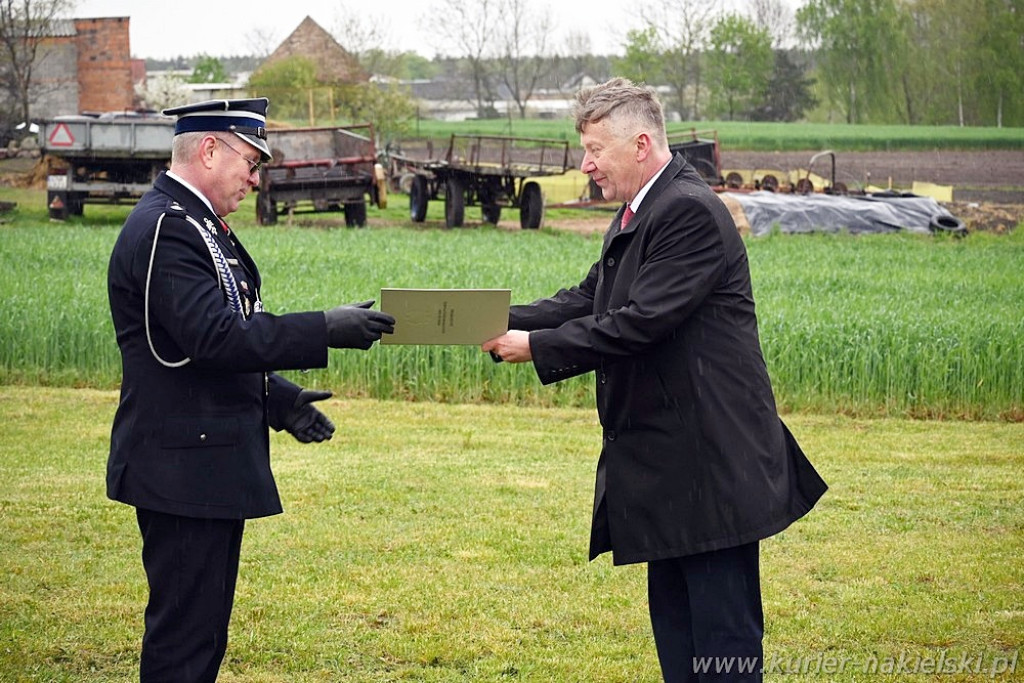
[0,386,1024,683]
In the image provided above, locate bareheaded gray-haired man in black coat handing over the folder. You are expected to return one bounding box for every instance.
[482,79,826,683]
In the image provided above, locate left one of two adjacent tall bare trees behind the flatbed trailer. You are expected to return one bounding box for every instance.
[423,0,502,115]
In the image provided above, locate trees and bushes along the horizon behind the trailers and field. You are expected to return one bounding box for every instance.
[0,0,1024,142]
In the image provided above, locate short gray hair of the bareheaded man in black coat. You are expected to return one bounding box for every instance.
[572,78,669,147]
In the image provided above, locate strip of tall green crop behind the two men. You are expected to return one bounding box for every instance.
[0,188,1024,420]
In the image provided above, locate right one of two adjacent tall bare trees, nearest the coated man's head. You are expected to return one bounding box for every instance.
[498,0,557,119]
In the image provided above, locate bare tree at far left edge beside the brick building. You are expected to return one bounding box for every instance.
[0,0,74,121]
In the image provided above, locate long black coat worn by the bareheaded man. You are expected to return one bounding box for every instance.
[509,156,826,564]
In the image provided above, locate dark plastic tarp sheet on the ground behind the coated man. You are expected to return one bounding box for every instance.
[726,191,962,236]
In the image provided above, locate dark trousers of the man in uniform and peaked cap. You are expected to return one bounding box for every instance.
[135,509,245,683]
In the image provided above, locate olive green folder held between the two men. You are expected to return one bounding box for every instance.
[380,288,512,344]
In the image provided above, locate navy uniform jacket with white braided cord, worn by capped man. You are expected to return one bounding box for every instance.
[106,175,327,519]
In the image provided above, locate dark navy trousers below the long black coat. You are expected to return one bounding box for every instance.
[647,542,764,683]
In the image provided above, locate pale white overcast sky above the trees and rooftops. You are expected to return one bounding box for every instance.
[75,0,790,58]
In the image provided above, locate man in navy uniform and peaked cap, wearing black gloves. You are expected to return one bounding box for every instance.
[106,98,394,683]
